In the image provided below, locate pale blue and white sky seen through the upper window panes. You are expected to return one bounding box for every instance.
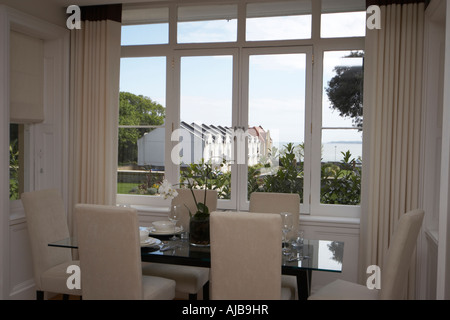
[120,12,366,151]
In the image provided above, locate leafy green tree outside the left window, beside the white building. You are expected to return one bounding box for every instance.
[119,92,166,164]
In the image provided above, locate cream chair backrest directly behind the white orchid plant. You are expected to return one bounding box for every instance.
[172,189,217,231]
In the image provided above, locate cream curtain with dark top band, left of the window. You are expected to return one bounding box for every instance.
[69,8,121,231]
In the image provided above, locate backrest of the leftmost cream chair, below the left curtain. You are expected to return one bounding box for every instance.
[21,189,72,290]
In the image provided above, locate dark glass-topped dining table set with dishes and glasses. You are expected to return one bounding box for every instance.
[48,228,344,300]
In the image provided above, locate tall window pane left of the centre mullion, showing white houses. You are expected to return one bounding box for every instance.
[180,55,233,199]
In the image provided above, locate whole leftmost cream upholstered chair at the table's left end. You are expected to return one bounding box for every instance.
[21,189,81,300]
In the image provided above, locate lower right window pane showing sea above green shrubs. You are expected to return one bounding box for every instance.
[320,129,362,205]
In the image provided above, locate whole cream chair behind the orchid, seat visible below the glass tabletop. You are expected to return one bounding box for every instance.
[142,189,217,300]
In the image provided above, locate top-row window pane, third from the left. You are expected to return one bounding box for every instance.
[246,0,311,41]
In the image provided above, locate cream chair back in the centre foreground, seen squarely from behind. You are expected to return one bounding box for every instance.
[210,211,281,300]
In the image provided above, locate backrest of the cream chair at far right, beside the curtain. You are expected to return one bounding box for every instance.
[380,210,424,300]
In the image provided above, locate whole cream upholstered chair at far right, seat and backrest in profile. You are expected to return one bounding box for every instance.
[309,209,424,300]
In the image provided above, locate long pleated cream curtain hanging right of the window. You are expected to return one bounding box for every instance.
[359,1,424,298]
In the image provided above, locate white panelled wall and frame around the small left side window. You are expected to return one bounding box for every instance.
[0,6,69,299]
